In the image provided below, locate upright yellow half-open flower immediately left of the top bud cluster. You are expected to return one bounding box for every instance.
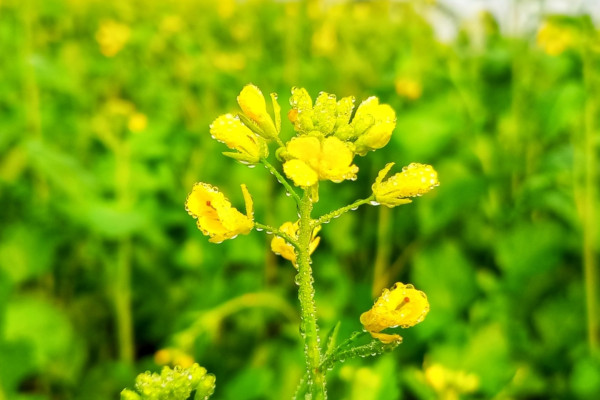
[237,84,281,139]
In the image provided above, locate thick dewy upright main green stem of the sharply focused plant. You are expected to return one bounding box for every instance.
[296,190,327,400]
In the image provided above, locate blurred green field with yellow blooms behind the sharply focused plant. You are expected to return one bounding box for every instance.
[0,0,600,400]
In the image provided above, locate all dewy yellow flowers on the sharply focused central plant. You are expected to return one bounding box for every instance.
[186,84,439,350]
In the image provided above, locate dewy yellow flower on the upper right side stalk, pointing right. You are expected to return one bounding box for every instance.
[372,163,440,207]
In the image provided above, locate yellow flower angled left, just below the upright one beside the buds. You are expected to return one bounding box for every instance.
[210,114,269,164]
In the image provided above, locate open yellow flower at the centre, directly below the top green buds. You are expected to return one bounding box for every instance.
[281,136,358,187]
